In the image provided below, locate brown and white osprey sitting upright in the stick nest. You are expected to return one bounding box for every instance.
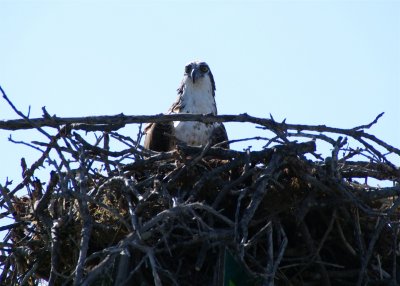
[144,61,229,151]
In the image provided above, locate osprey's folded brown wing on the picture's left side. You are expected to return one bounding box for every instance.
[144,122,175,152]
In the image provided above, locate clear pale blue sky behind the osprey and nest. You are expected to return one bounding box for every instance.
[0,0,400,184]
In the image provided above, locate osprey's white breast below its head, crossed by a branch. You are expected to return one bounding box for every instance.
[174,77,217,146]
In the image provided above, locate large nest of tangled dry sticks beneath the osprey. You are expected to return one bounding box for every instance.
[0,88,400,285]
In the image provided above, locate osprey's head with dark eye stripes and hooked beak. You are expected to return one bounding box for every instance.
[183,61,215,95]
